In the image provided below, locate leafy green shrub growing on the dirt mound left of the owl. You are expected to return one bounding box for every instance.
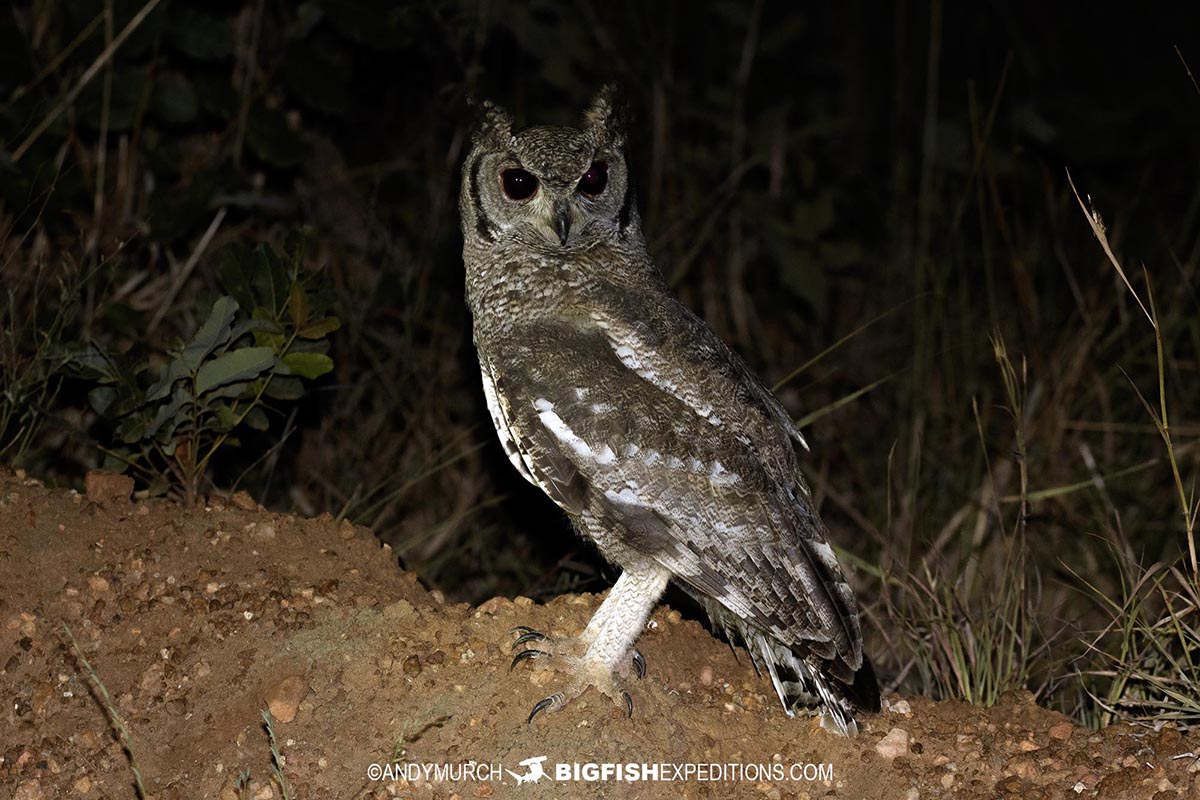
[70,239,341,503]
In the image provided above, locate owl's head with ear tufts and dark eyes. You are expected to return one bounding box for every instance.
[460,86,637,252]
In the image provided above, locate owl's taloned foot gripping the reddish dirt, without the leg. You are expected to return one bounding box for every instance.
[509,626,646,722]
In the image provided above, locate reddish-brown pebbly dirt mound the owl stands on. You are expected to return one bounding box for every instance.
[0,473,1200,800]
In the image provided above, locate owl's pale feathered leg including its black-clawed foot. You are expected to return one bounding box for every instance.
[514,560,671,722]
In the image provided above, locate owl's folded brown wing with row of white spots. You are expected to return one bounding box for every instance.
[490,318,862,672]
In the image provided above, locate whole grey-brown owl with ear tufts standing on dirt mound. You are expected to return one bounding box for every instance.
[460,86,880,734]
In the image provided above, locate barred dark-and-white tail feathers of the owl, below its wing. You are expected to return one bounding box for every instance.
[703,601,881,736]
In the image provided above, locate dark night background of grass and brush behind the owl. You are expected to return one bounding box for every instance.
[0,0,1200,714]
